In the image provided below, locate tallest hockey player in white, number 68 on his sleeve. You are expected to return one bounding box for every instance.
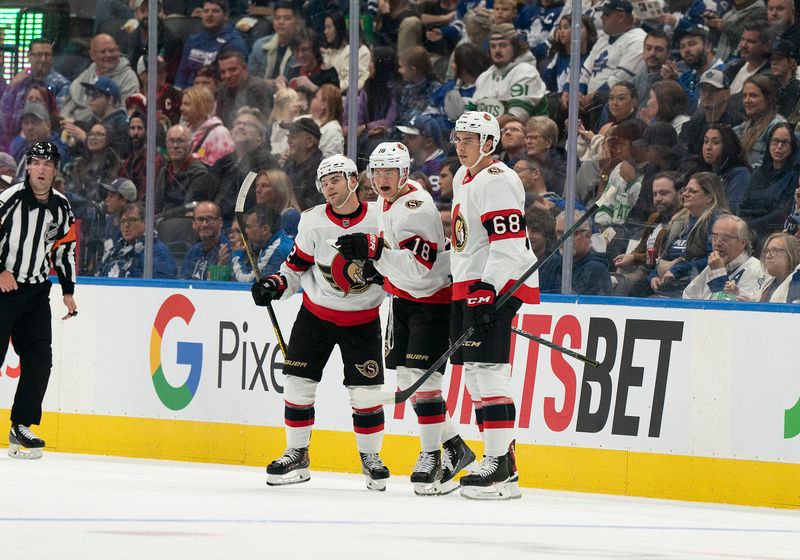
[450,111,539,499]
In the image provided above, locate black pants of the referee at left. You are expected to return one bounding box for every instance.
[0,280,53,426]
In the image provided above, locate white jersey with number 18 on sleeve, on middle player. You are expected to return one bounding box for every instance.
[375,181,452,303]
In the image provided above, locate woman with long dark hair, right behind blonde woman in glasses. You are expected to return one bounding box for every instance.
[702,124,750,214]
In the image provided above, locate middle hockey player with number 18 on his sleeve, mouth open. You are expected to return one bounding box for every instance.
[337,142,475,495]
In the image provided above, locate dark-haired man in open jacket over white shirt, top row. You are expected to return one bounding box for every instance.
[247,0,298,88]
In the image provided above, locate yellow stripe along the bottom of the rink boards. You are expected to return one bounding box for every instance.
[0,409,800,509]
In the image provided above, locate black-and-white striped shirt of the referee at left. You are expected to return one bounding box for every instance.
[0,181,76,294]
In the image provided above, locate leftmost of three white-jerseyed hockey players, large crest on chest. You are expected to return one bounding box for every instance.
[252,155,389,490]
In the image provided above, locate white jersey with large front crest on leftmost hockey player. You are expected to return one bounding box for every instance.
[281,202,386,327]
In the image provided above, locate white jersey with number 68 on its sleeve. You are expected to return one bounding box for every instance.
[450,161,539,303]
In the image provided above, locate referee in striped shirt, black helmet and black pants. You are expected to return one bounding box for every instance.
[0,142,78,459]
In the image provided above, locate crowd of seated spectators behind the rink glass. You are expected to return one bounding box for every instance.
[0,0,800,301]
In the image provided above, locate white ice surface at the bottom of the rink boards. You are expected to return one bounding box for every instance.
[0,450,800,560]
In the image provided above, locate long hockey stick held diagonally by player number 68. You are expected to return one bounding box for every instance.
[353,186,617,404]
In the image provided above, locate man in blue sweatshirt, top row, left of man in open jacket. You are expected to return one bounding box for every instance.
[175,0,248,89]
